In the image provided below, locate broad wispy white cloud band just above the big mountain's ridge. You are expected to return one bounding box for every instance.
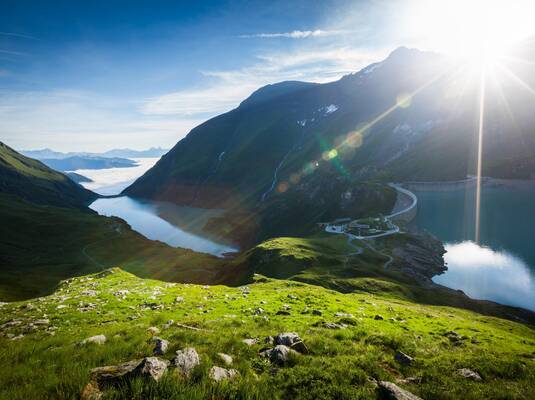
[141,47,386,117]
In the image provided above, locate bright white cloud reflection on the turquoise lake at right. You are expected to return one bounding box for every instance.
[433,241,535,310]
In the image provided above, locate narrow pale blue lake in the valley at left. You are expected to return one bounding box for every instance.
[90,196,237,257]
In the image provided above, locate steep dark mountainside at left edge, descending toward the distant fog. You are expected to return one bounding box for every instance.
[0,142,97,208]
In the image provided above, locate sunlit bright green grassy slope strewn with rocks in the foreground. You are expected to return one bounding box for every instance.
[0,270,535,400]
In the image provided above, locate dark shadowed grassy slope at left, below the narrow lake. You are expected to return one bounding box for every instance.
[0,193,239,300]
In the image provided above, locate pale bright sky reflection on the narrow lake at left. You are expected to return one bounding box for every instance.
[90,196,237,257]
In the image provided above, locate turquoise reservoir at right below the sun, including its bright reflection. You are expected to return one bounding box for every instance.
[412,185,535,310]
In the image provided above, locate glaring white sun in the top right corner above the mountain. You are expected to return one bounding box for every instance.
[404,0,535,69]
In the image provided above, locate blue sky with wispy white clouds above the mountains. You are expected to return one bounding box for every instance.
[0,0,531,151]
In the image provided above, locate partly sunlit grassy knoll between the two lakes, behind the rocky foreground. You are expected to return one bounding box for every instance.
[233,233,535,324]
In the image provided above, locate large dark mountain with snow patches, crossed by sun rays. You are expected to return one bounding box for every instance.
[125,47,535,212]
